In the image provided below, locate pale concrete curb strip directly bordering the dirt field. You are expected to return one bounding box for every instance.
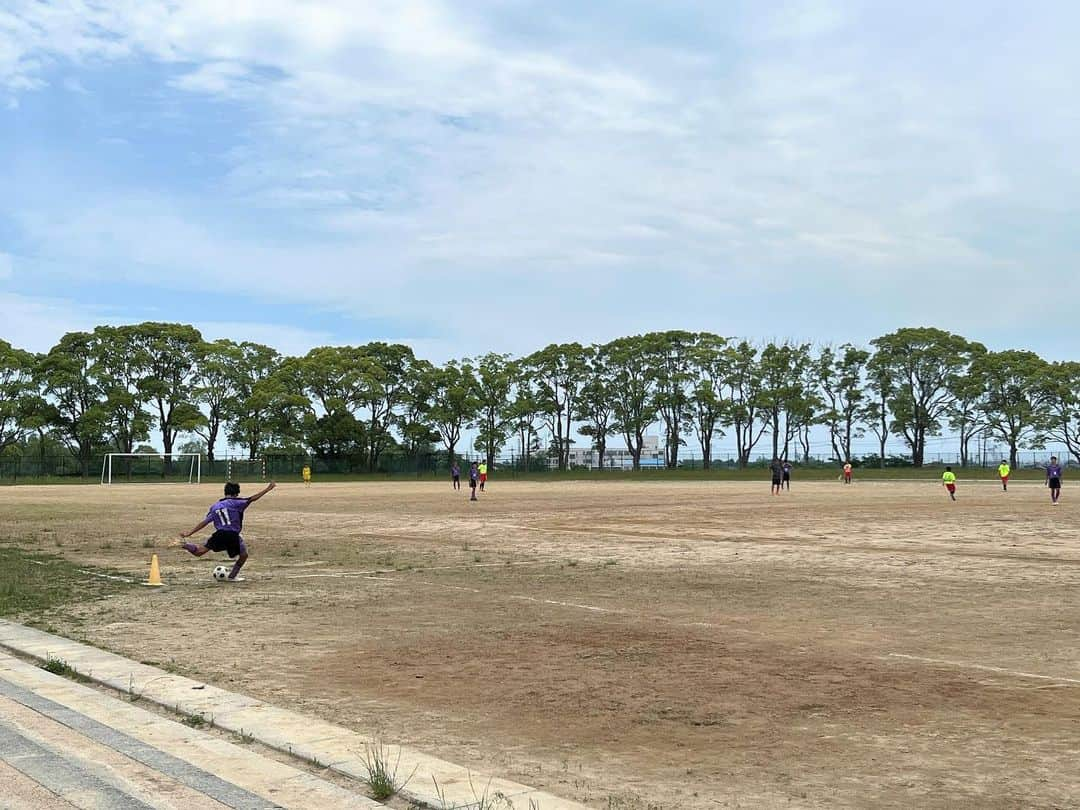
[0,620,588,810]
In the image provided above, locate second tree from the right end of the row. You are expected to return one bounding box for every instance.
[972,350,1051,464]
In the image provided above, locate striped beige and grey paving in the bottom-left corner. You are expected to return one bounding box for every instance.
[0,659,374,810]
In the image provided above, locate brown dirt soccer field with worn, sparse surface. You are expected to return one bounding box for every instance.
[0,480,1080,810]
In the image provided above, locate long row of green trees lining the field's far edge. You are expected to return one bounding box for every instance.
[0,323,1080,471]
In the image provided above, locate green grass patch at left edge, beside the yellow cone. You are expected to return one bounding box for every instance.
[0,546,130,616]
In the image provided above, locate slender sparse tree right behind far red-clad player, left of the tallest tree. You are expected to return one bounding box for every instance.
[814,343,870,462]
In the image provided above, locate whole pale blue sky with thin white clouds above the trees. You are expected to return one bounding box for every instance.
[0,0,1080,360]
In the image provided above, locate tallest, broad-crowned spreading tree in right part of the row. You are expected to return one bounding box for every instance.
[870,327,972,467]
